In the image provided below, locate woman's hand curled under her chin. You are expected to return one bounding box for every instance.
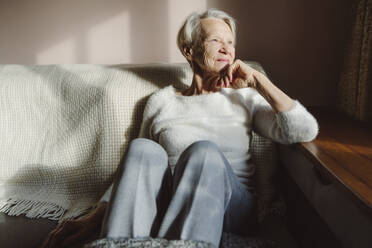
[217,59,260,89]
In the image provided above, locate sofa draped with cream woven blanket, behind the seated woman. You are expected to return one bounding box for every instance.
[0,61,297,247]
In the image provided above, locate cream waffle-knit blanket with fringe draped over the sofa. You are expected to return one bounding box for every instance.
[0,65,195,219]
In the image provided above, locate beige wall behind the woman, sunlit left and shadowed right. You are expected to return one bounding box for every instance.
[0,0,351,105]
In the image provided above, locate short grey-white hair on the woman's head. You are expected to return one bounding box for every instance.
[177,9,236,58]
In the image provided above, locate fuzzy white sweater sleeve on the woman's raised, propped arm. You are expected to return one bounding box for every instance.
[253,96,318,144]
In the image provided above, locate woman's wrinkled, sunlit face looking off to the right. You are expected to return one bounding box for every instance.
[193,18,235,73]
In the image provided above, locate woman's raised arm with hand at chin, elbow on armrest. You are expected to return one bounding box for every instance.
[222,60,318,144]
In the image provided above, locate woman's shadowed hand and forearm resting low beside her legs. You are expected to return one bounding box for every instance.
[42,202,107,248]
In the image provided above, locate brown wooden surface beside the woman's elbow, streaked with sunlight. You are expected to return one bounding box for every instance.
[297,108,372,216]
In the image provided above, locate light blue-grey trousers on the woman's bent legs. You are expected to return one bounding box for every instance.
[101,138,256,247]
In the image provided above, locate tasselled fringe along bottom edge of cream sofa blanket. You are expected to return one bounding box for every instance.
[0,198,66,220]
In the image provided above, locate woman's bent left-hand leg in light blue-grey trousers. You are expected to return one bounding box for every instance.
[101,138,171,238]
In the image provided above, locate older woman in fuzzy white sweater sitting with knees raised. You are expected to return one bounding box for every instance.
[45,9,318,247]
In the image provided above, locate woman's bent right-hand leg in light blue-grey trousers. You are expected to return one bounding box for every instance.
[158,141,253,247]
